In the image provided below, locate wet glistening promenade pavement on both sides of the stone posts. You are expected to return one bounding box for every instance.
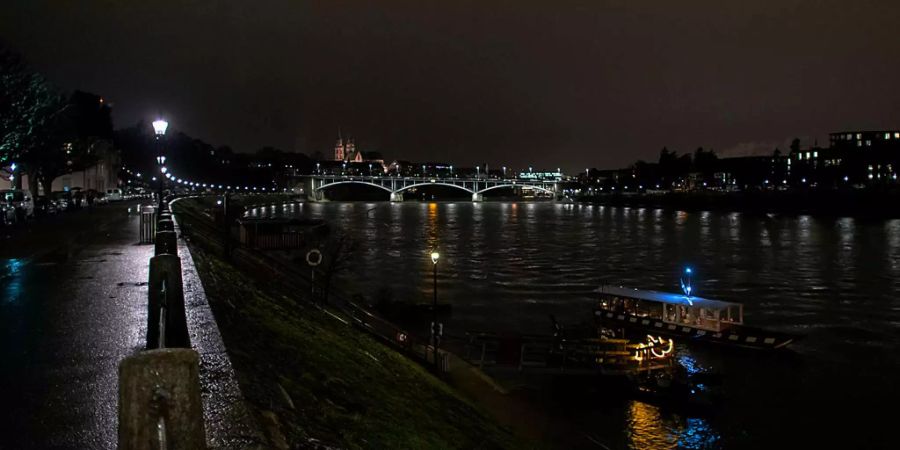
[0,203,254,449]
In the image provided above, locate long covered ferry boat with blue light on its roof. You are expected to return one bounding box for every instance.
[594,269,800,349]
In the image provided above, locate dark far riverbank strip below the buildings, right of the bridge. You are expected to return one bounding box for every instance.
[579,189,900,219]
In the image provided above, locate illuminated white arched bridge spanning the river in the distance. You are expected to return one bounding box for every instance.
[305,175,559,202]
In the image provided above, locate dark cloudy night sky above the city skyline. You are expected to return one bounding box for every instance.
[0,0,900,170]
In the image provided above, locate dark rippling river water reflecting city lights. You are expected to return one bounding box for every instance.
[251,202,900,449]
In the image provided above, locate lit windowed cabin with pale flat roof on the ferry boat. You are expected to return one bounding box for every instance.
[596,286,744,332]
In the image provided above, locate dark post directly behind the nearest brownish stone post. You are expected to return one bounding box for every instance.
[147,255,191,349]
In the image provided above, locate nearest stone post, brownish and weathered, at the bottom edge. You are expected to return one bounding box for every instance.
[118,348,206,450]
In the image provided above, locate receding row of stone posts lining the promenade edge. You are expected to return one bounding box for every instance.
[119,202,206,450]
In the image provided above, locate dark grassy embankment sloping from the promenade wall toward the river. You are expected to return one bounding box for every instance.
[175,199,522,449]
